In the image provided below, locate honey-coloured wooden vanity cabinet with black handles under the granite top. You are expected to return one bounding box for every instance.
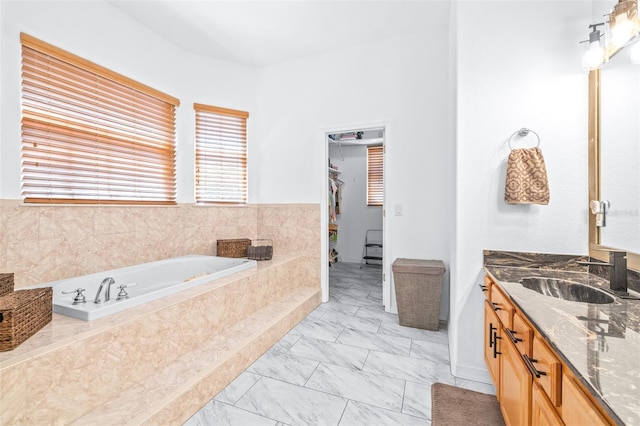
[482,276,614,426]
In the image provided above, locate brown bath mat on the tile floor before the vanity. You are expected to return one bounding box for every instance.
[431,383,504,426]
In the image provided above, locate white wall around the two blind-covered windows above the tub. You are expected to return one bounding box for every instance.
[0,0,257,203]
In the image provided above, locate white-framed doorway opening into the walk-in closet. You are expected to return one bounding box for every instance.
[321,124,391,312]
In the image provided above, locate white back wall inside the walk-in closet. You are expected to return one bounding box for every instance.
[329,145,382,263]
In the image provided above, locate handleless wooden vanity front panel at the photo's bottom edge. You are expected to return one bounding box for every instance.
[562,374,609,426]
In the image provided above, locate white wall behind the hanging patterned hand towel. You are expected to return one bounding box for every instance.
[449,1,591,379]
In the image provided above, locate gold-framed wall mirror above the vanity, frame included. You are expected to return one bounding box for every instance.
[589,37,640,271]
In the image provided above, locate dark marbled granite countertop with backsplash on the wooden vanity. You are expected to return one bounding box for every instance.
[484,251,640,425]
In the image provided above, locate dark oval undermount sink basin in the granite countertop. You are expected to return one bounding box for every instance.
[520,277,615,304]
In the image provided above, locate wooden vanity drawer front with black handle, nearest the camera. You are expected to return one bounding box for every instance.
[523,337,562,407]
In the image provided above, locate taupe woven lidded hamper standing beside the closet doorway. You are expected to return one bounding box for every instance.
[391,259,444,330]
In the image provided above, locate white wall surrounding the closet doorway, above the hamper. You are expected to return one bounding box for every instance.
[254,2,454,317]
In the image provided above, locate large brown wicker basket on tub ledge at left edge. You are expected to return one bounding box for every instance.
[0,287,53,352]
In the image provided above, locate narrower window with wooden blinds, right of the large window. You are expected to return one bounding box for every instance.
[193,104,249,204]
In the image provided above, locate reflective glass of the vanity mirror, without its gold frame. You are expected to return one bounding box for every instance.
[600,40,640,253]
